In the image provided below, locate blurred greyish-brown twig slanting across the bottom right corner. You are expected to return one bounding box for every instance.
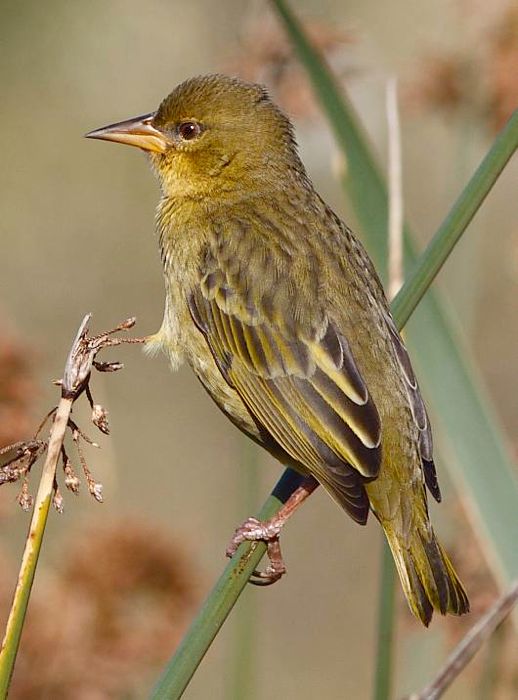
[408,580,518,700]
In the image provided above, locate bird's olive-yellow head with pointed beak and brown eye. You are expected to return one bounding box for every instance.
[87,75,304,197]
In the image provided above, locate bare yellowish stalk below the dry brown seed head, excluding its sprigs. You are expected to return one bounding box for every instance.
[0,398,73,698]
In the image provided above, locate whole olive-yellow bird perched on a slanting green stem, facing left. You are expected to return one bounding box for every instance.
[86,74,469,626]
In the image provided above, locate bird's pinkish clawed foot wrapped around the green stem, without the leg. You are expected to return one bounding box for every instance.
[227,517,286,586]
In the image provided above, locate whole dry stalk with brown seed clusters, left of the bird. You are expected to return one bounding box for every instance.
[0,314,143,697]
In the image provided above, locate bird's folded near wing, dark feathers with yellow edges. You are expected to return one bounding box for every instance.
[189,273,381,522]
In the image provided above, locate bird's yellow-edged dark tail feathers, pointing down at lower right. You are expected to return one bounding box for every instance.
[385,523,469,627]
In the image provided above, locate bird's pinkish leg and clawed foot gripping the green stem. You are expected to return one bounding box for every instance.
[227,476,318,586]
